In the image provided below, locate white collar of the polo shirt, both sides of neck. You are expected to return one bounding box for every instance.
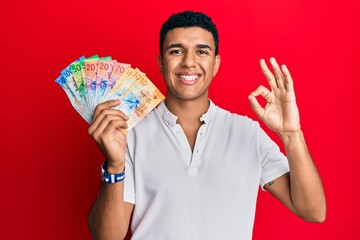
[156,99,216,127]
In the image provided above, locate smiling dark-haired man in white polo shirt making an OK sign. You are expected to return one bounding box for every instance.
[89,11,326,240]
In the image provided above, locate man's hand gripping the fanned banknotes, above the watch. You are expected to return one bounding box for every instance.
[88,100,129,173]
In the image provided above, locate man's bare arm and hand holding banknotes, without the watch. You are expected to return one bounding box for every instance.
[88,100,134,239]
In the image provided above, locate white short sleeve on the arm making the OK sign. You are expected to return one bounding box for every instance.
[257,126,290,190]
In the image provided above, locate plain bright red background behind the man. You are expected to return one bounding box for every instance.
[0,0,360,240]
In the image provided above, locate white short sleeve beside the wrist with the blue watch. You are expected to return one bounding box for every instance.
[124,142,135,204]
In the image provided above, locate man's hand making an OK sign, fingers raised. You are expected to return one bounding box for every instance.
[249,58,300,135]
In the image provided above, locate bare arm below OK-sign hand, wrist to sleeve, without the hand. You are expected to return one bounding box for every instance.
[265,132,326,223]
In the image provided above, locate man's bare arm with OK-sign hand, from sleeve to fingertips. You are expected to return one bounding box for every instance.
[249,58,326,222]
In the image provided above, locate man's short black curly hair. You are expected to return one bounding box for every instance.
[160,11,219,56]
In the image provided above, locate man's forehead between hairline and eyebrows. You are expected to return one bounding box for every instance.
[163,27,215,48]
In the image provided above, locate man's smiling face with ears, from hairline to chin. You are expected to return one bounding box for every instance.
[159,27,220,100]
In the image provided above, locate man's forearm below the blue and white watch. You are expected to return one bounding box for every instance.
[89,166,130,240]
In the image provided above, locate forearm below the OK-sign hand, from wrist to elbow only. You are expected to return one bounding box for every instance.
[280,131,326,222]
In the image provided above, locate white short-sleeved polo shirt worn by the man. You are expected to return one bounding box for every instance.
[124,101,289,240]
